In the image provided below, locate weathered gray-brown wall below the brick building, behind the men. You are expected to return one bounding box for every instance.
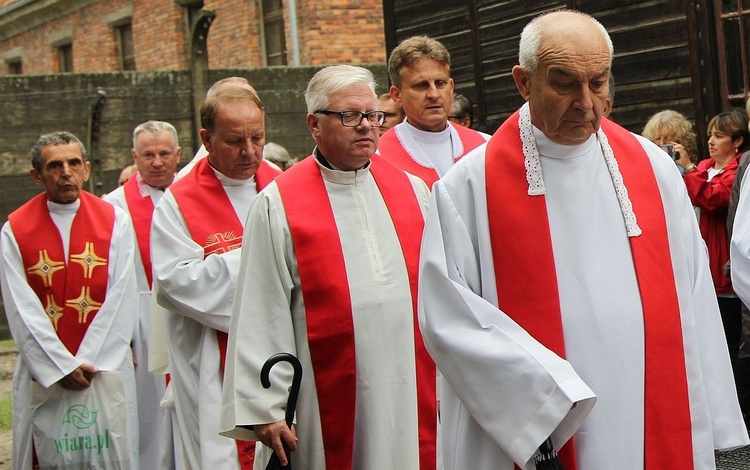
[0,64,388,339]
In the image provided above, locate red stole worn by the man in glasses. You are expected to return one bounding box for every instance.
[276,155,437,470]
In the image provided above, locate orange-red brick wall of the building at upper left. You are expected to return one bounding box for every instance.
[0,0,385,75]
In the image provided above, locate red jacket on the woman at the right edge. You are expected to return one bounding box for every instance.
[685,154,741,294]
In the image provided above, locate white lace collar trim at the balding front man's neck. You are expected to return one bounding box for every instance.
[518,102,643,237]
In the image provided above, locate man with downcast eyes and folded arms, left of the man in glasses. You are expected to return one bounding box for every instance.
[151,86,279,470]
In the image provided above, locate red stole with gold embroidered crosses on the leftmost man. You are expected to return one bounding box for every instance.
[8,191,115,355]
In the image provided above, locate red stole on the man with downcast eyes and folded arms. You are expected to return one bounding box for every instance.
[170,158,280,469]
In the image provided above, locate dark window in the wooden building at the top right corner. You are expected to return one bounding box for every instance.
[714,0,750,107]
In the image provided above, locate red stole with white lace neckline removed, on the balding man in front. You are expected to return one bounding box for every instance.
[485,112,693,470]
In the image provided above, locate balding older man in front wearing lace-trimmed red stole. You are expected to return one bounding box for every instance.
[419,11,748,470]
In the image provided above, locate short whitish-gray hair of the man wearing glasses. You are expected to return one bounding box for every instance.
[305,65,377,113]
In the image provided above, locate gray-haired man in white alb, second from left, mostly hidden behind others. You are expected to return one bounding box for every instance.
[104,121,181,469]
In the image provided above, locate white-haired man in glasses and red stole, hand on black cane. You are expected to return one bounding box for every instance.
[221,65,437,470]
